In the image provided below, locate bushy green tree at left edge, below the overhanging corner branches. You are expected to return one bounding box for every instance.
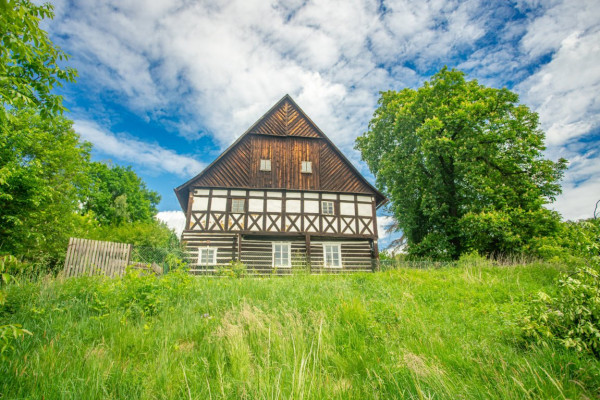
[0,108,90,259]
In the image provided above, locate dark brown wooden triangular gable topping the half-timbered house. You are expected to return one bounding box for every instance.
[175,95,385,211]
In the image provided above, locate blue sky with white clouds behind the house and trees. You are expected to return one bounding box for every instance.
[43,0,600,244]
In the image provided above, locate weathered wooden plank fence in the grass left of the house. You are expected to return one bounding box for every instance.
[64,238,131,277]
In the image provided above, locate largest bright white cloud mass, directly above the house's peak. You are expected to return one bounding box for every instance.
[49,0,492,149]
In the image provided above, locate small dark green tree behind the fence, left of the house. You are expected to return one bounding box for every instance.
[82,162,160,225]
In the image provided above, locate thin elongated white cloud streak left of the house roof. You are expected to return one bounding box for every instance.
[73,120,204,177]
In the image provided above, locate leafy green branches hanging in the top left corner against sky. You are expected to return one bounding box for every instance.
[0,0,76,119]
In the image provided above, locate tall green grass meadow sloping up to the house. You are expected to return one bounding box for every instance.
[0,264,600,399]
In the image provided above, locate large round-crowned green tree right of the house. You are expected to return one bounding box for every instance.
[356,67,567,259]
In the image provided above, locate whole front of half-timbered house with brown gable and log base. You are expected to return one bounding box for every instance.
[175,95,386,272]
